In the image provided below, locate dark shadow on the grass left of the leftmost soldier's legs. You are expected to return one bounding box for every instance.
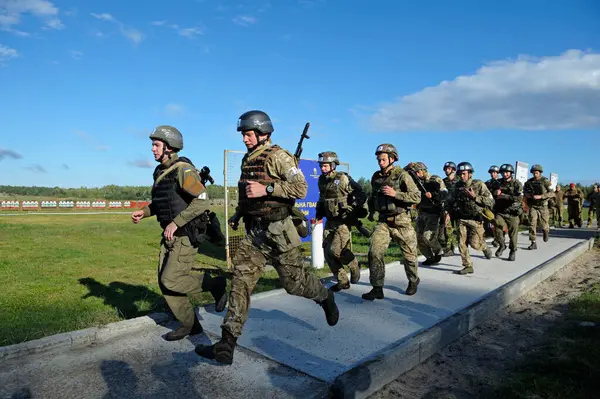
[78,277,169,319]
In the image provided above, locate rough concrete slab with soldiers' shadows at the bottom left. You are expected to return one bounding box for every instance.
[0,326,328,399]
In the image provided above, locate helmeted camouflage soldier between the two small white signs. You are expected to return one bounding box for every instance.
[523,164,554,249]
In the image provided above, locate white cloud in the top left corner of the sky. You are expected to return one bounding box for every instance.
[0,0,64,32]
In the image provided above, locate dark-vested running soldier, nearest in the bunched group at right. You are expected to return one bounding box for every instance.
[447,162,494,274]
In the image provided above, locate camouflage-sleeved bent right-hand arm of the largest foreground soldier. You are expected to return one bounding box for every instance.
[267,150,308,199]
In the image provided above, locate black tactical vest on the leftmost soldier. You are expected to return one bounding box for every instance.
[151,157,195,229]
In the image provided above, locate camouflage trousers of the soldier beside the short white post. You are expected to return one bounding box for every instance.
[323,219,360,285]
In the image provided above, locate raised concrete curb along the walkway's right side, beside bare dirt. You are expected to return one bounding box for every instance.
[331,238,594,398]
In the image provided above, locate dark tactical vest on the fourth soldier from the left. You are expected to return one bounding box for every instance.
[371,166,412,216]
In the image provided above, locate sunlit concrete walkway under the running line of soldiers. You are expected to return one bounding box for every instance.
[199,236,585,383]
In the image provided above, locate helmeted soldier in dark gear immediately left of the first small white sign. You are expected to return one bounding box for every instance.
[492,163,523,261]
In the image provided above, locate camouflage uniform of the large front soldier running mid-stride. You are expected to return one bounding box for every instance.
[221,143,327,337]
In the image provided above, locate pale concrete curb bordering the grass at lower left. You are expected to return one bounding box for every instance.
[0,313,170,361]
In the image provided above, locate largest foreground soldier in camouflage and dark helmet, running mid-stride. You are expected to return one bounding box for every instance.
[196,111,339,364]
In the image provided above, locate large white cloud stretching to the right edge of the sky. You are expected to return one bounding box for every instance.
[371,50,600,132]
